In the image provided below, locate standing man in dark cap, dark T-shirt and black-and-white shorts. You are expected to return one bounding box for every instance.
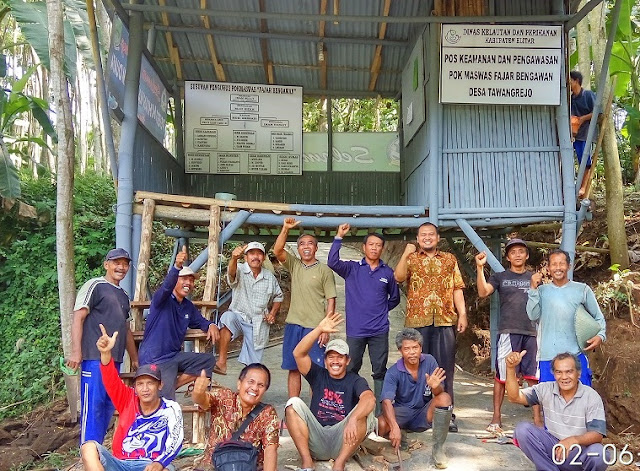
[476,239,542,433]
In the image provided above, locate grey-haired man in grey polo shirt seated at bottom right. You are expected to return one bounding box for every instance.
[506,351,608,471]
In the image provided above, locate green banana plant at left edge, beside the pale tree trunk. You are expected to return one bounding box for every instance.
[0,67,57,199]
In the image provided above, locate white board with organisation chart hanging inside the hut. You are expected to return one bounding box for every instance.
[184,81,302,175]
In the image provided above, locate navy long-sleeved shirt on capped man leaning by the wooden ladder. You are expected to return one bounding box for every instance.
[139,266,213,365]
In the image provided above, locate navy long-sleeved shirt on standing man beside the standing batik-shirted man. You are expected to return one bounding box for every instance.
[327,239,400,338]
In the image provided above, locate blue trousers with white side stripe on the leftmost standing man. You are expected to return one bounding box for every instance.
[80,360,120,445]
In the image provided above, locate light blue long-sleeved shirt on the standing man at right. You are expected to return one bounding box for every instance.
[527,281,607,361]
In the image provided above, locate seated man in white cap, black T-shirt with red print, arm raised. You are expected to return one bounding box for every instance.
[285,313,376,471]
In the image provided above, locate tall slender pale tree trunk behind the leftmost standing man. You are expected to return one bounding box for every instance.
[47,0,77,411]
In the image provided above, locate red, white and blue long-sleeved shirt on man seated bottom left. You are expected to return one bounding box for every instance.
[100,360,184,468]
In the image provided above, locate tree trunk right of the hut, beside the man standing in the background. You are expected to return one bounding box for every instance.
[589,3,629,269]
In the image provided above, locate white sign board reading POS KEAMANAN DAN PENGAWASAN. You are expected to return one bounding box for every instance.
[440,24,563,105]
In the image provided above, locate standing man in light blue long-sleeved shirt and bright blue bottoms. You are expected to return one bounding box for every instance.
[527,249,607,386]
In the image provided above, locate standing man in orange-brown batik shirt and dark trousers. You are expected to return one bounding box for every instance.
[395,222,468,432]
